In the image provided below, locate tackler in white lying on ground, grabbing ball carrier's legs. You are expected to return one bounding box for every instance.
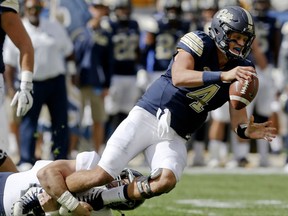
[0,151,143,216]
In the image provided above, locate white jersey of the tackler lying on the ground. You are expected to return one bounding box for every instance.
[3,152,111,216]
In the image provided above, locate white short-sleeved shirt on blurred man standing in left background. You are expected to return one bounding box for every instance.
[3,18,73,81]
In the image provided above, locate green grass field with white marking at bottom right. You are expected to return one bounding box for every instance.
[114,173,288,216]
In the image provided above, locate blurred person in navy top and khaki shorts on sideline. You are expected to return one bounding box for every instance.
[74,0,113,153]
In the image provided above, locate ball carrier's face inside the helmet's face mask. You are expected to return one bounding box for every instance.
[228,32,249,55]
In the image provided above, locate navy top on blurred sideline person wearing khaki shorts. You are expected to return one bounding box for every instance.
[74,20,113,88]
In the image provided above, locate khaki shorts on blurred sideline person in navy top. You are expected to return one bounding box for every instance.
[80,87,107,123]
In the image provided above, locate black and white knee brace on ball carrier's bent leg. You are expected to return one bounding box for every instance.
[136,168,163,199]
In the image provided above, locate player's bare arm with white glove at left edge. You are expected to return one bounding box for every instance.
[0,0,34,116]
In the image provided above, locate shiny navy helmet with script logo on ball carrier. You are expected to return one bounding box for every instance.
[209,6,255,59]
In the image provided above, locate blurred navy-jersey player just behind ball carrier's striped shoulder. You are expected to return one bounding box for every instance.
[142,0,190,86]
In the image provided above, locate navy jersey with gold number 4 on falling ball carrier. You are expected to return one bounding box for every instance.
[137,31,254,137]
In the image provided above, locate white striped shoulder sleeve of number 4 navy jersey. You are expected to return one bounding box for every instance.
[180,32,204,57]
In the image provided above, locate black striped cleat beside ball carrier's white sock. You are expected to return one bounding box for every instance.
[76,187,104,211]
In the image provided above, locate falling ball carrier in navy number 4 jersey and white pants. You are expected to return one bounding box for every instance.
[38,6,275,210]
